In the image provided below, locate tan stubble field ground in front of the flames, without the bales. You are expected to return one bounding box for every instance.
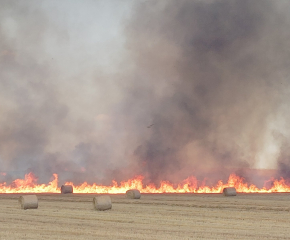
[0,193,290,240]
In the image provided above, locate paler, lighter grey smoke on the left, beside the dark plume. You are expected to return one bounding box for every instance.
[0,1,130,182]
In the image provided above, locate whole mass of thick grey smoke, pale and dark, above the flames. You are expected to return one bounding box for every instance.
[0,0,290,186]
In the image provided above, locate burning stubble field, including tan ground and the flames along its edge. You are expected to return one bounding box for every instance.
[0,171,290,240]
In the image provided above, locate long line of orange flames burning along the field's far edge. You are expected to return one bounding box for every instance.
[0,173,290,194]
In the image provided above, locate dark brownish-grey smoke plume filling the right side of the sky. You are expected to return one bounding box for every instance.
[120,0,290,182]
